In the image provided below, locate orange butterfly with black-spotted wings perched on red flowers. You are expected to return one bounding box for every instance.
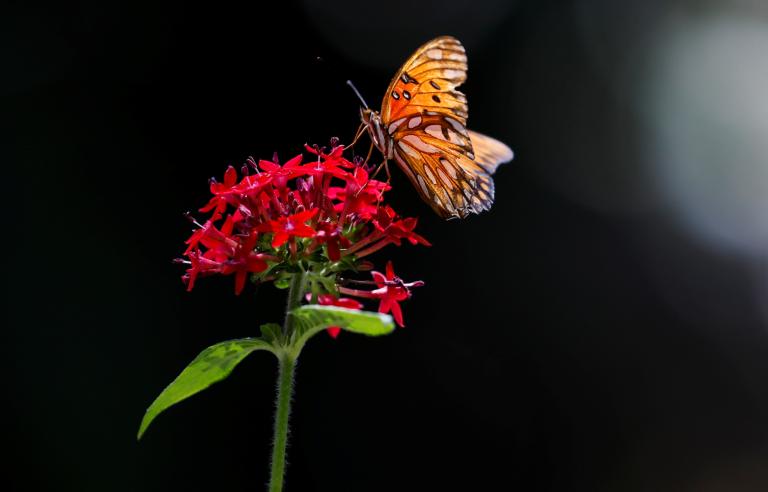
[360,36,513,218]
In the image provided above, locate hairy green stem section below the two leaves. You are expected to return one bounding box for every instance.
[269,352,296,492]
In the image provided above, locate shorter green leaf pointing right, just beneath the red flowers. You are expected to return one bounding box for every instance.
[291,304,395,350]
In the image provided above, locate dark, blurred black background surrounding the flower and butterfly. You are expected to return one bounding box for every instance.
[6,0,768,491]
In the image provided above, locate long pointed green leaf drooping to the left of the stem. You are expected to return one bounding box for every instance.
[137,338,274,439]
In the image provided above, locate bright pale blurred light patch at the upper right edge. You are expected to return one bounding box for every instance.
[644,16,768,257]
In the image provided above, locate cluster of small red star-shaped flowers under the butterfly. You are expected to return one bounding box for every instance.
[178,139,430,336]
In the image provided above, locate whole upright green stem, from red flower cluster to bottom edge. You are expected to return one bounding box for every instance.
[269,272,305,492]
